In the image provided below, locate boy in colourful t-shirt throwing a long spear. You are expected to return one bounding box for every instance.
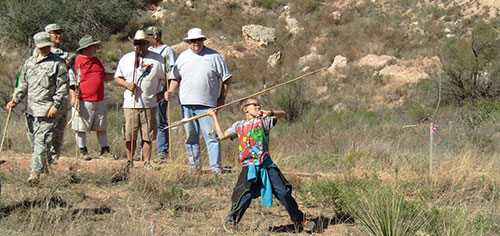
[209,97,315,233]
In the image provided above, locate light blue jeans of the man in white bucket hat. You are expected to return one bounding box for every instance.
[182,105,222,171]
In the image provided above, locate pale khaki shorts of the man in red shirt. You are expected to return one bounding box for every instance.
[71,100,108,132]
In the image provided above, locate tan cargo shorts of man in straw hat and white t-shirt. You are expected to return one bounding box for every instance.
[123,107,158,142]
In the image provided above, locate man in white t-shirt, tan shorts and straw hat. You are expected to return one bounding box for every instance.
[115,30,165,170]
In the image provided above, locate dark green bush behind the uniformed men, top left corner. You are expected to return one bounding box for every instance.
[0,0,143,48]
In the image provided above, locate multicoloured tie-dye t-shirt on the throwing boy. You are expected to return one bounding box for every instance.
[226,117,276,166]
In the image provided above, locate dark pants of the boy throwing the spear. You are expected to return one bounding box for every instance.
[226,168,304,224]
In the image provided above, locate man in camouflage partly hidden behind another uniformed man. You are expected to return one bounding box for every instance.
[26,24,76,163]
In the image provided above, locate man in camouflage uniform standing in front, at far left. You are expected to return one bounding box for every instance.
[7,32,69,184]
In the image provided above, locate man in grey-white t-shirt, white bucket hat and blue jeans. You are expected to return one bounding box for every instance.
[165,28,232,173]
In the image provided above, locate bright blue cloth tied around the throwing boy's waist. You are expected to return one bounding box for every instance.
[247,156,276,207]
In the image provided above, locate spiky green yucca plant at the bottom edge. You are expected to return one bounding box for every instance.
[352,188,426,236]
